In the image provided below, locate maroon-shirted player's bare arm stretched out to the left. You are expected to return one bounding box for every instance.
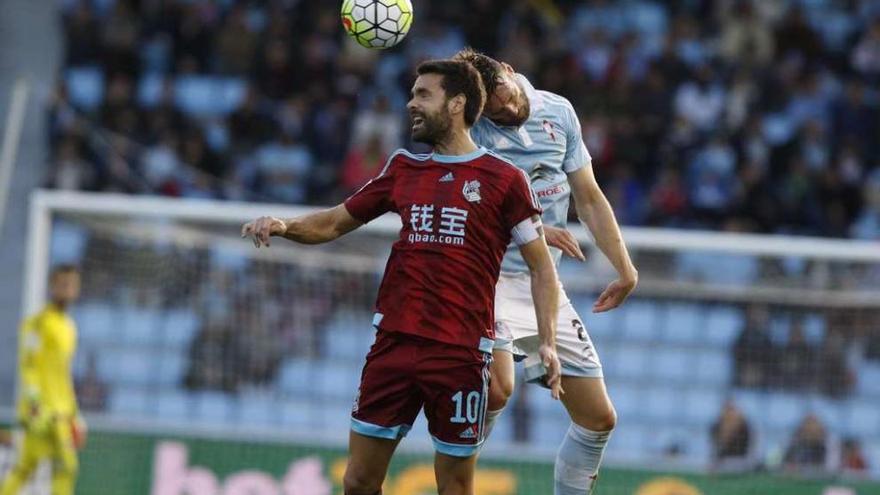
[241,205,363,248]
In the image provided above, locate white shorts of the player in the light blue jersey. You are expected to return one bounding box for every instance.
[494,273,603,382]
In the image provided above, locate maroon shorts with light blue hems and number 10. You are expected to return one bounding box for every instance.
[351,330,492,457]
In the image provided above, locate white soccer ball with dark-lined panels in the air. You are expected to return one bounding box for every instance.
[342,0,412,50]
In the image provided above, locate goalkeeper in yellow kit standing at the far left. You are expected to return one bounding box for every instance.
[0,265,85,495]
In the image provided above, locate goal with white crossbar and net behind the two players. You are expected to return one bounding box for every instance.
[8,192,880,495]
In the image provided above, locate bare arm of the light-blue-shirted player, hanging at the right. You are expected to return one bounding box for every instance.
[568,165,639,313]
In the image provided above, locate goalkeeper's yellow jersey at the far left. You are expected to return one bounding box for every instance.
[18,304,79,422]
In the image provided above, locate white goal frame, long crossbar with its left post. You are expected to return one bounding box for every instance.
[22,190,880,314]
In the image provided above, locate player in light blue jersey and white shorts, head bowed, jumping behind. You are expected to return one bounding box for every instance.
[455,49,638,495]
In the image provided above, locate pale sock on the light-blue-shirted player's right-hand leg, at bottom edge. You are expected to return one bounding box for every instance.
[553,423,611,495]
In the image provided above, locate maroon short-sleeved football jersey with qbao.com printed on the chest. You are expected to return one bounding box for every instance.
[345,148,541,352]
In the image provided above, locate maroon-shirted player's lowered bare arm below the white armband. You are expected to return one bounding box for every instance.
[519,229,564,399]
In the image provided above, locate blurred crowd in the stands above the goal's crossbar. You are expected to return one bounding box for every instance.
[47,0,880,239]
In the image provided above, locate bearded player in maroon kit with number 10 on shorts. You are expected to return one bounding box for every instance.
[242,61,561,495]
